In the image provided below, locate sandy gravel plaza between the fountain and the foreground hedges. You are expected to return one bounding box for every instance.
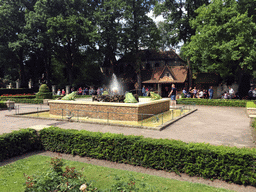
[0,104,255,147]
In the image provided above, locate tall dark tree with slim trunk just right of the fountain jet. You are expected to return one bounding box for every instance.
[122,0,160,89]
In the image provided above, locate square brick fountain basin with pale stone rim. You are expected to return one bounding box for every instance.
[48,98,170,121]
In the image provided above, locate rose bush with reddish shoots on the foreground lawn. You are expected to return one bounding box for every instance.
[25,158,98,192]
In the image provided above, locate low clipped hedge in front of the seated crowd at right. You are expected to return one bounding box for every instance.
[177,98,247,107]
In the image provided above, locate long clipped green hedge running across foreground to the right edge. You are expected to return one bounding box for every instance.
[40,127,256,186]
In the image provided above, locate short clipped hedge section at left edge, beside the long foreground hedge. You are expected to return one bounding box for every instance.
[0,129,42,161]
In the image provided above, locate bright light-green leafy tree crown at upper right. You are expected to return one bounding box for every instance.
[182,0,256,95]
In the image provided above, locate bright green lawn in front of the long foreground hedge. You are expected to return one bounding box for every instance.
[0,155,234,192]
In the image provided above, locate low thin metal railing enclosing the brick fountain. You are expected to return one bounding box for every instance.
[15,103,195,127]
